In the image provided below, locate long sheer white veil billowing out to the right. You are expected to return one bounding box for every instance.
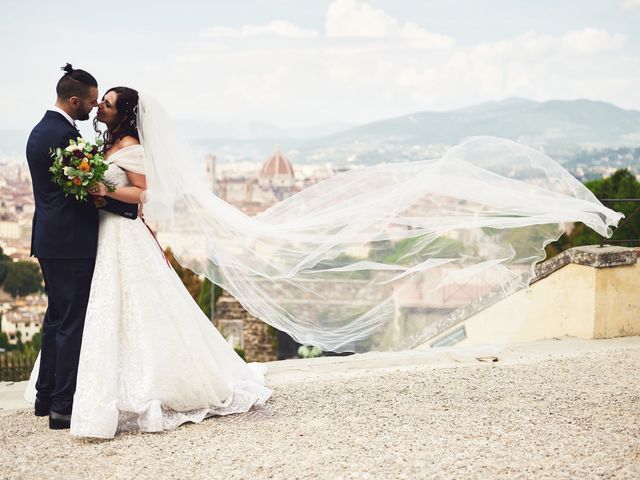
[138,95,622,352]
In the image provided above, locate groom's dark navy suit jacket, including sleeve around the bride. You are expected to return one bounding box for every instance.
[27,110,138,259]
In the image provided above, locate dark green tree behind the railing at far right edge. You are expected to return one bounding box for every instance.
[547,168,640,257]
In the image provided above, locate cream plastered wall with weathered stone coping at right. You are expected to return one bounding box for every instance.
[417,247,640,349]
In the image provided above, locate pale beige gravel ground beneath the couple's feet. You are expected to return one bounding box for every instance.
[0,348,640,480]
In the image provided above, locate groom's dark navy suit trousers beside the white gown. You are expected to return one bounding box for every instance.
[36,258,95,415]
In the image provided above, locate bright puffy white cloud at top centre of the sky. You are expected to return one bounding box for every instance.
[325,0,455,49]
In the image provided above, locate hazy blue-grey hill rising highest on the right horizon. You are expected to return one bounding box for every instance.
[307,98,640,156]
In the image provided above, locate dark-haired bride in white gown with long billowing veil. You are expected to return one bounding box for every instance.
[27,87,621,438]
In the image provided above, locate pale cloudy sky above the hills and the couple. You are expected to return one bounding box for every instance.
[0,0,640,129]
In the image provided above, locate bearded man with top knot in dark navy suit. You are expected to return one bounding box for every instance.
[26,64,138,429]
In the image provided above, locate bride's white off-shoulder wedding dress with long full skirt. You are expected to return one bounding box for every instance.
[26,145,272,438]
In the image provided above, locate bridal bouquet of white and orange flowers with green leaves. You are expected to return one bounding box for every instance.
[49,137,113,207]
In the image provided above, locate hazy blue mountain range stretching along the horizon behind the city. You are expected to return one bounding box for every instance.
[0,98,640,164]
